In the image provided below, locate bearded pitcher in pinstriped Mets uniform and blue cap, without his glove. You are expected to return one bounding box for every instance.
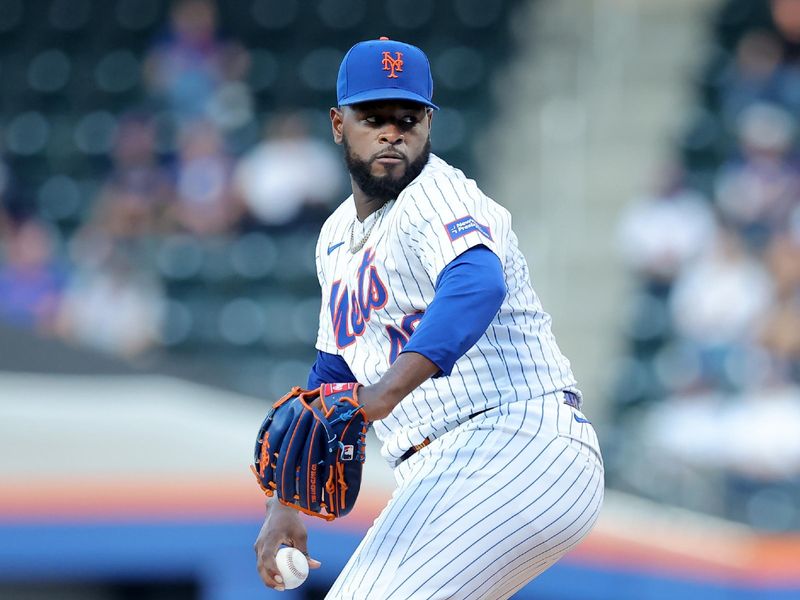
[255,38,603,600]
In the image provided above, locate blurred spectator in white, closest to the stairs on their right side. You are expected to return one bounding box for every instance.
[617,164,714,285]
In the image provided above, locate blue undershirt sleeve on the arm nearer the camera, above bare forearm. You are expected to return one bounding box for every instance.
[403,246,506,377]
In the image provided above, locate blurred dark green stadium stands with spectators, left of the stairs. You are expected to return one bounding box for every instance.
[0,0,513,397]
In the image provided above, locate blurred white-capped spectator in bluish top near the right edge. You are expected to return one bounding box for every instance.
[716,104,800,247]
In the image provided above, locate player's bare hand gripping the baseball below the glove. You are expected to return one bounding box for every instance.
[253,498,321,592]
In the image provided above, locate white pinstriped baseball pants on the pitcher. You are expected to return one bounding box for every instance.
[326,392,603,600]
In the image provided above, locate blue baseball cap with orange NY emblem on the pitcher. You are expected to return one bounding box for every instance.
[336,37,439,109]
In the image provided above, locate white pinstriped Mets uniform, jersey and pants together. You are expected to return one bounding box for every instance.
[317,156,603,600]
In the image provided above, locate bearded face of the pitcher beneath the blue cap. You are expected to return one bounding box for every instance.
[331,101,432,200]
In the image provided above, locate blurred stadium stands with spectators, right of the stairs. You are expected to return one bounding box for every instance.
[611,0,800,530]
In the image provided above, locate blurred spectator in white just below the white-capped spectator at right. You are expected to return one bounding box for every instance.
[670,230,772,384]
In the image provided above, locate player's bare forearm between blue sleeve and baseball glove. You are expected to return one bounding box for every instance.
[358,352,439,421]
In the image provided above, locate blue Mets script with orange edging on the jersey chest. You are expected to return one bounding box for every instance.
[330,248,389,348]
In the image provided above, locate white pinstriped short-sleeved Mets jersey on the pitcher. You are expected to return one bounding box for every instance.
[316,155,577,464]
